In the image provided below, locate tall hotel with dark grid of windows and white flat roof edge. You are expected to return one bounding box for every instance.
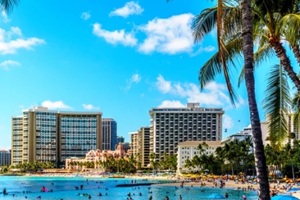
[150,103,224,159]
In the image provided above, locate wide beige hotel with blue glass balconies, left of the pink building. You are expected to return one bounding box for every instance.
[11,107,102,167]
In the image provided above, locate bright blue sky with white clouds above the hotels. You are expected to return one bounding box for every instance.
[0,0,282,149]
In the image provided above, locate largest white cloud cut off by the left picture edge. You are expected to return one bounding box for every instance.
[0,27,45,54]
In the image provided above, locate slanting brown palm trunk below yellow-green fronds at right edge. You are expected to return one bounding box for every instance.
[269,36,300,92]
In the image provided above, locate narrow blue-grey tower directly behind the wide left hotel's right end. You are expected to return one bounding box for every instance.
[102,118,118,150]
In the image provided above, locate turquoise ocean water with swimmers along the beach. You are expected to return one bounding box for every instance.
[0,176,257,200]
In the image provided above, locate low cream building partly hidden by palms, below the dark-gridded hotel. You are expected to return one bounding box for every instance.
[177,141,222,173]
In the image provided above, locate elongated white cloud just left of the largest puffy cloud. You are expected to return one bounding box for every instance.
[93,23,137,46]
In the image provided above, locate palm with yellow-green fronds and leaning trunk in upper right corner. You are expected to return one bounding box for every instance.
[254,0,300,92]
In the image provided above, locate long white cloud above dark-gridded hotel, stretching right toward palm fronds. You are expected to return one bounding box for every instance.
[156,75,236,107]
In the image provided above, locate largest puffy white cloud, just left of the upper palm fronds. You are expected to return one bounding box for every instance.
[139,13,194,54]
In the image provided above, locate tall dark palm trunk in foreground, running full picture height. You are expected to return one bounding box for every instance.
[241,0,270,200]
